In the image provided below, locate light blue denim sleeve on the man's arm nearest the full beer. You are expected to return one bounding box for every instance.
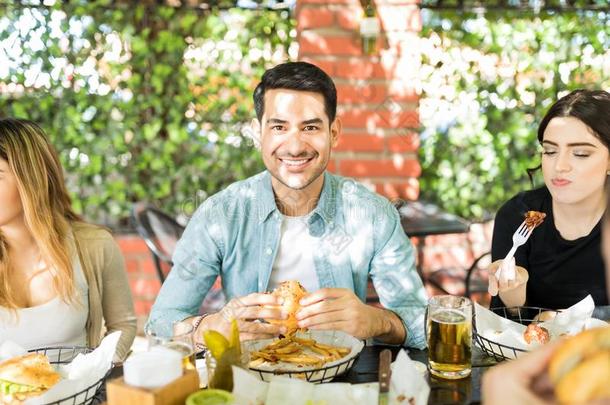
[370,203,428,349]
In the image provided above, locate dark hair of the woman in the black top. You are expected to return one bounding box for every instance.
[527,89,610,184]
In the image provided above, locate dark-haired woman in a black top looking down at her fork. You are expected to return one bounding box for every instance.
[490,90,610,309]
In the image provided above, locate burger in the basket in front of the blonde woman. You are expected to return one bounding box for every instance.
[0,353,60,405]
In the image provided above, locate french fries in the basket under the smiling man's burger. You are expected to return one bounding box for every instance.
[250,334,350,368]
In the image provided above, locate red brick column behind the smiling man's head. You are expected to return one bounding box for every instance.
[296,0,421,199]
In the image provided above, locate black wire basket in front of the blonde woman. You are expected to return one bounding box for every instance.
[29,346,112,405]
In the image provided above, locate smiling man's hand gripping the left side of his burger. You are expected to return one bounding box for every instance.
[195,293,285,341]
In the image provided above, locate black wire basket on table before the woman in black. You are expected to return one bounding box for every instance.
[472,307,559,361]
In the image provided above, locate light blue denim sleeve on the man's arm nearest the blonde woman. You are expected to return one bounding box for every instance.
[148,199,222,327]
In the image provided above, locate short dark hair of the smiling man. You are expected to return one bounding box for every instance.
[254,62,337,123]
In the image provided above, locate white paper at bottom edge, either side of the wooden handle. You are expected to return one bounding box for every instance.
[233,350,430,405]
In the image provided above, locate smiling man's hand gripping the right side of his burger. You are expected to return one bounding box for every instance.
[297,288,405,343]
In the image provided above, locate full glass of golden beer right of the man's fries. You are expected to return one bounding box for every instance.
[426,295,472,379]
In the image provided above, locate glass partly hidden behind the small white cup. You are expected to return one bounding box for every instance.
[144,322,196,370]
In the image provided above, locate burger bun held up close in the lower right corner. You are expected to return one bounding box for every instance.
[549,326,610,404]
